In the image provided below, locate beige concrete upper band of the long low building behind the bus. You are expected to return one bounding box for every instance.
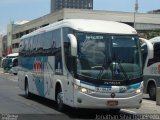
[8,9,160,53]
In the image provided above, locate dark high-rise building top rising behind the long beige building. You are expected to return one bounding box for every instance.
[51,0,93,12]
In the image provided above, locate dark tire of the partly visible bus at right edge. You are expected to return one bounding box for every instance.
[148,83,156,100]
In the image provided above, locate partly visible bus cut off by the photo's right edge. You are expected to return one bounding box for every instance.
[142,37,160,100]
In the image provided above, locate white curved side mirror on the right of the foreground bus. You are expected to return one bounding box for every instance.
[140,38,154,59]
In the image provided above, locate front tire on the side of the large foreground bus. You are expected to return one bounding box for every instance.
[56,88,65,111]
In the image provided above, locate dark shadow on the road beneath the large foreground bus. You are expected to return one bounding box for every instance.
[19,94,134,120]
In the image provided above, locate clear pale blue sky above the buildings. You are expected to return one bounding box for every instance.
[0,0,160,34]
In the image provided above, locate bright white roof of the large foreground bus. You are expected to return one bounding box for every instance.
[22,19,137,38]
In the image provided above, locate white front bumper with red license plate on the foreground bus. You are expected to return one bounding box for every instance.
[74,92,143,109]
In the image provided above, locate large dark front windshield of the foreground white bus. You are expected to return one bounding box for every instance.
[76,32,142,80]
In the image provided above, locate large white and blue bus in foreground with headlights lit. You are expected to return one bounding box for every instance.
[18,19,152,111]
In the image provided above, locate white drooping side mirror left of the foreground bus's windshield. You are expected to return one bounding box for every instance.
[68,34,77,57]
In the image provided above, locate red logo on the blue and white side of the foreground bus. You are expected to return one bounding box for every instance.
[33,61,43,77]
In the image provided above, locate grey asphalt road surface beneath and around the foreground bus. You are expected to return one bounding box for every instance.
[0,73,160,120]
